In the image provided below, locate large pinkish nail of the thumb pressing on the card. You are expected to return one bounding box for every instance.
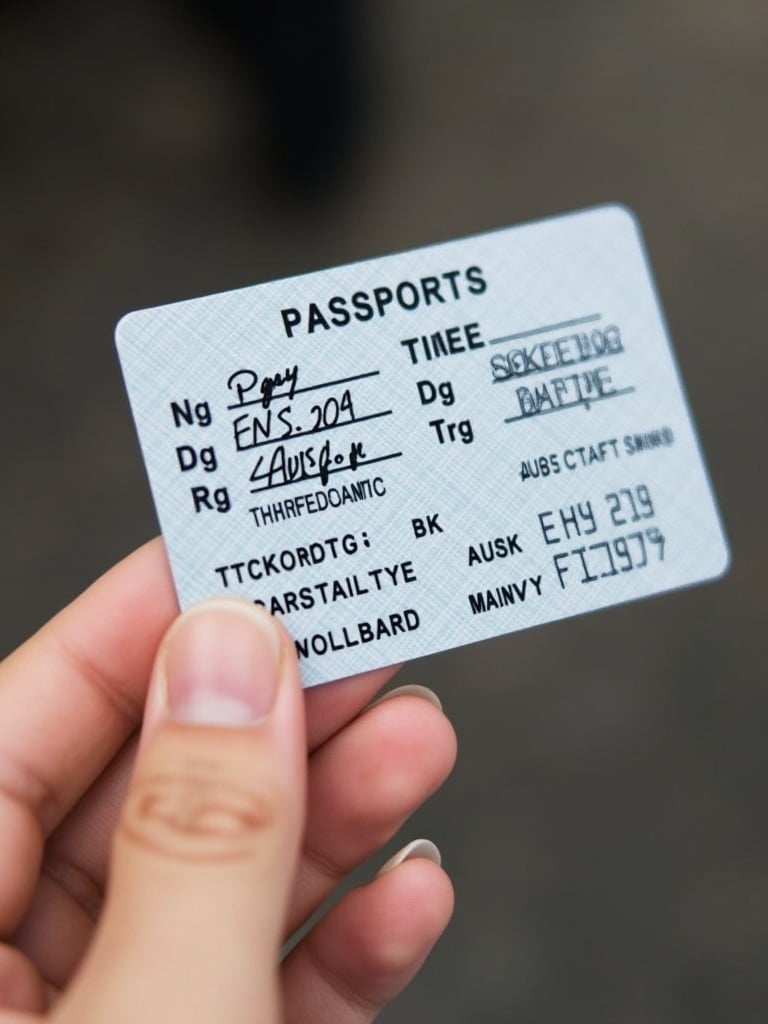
[160,600,280,725]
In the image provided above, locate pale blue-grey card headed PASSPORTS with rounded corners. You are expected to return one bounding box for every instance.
[117,206,728,685]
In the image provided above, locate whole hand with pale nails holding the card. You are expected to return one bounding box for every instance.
[0,541,455,1024]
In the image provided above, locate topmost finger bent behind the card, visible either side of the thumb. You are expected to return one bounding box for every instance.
[0,538,395,835]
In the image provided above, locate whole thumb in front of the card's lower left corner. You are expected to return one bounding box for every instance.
[60,600,306,1024]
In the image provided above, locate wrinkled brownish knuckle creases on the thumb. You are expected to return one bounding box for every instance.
[122,765,278,861]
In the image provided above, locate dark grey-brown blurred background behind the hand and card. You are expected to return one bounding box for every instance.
[0,0,768,1024]
